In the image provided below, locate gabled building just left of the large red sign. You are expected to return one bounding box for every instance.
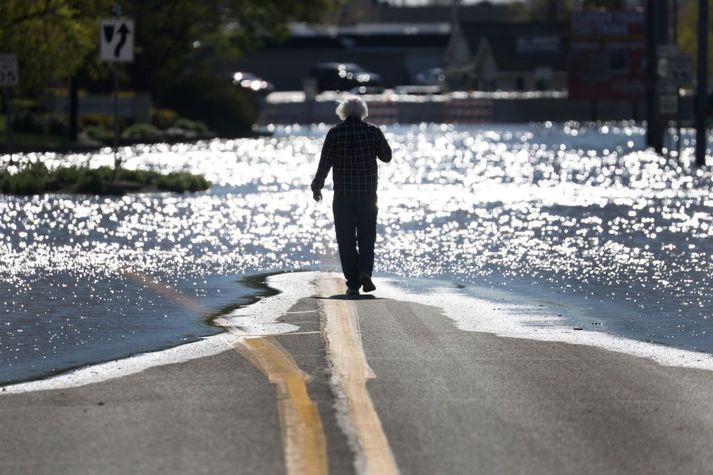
[444,22,569,91]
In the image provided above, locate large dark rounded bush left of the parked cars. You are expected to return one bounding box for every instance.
[157,73,257,137]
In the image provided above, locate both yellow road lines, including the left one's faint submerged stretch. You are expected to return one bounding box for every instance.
[127,273,398,475]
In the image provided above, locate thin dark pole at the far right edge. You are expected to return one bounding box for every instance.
[696,0,708,167]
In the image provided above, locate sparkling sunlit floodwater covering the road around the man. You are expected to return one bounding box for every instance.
[0,123,713,383]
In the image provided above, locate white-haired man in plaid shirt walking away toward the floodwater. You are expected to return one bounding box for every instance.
[312,97,391,295]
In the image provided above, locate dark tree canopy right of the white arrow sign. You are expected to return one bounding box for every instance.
[122,0,333,94]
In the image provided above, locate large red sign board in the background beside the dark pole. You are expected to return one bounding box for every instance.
[569,10,646,99]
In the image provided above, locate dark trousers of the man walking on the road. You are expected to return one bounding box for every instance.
[332,196,377,289]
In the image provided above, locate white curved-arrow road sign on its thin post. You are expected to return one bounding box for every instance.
[99,5,135,170]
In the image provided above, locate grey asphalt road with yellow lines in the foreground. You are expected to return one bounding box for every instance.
[0,274,713,474]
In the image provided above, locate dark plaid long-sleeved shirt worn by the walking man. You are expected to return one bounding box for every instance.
[312,117,391,198]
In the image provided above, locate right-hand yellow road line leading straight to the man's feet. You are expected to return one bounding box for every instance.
[318,274,399,475]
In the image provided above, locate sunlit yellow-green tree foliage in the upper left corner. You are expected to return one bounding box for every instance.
[0,0,111,94]
